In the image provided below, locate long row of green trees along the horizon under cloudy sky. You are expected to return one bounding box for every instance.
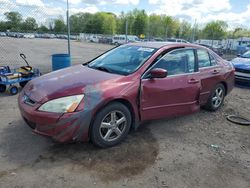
[0,9,250,41]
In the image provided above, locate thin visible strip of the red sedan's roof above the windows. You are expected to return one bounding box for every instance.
[127,42,204,49]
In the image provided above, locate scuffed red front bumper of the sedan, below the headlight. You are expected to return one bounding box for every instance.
[18,92,91,142]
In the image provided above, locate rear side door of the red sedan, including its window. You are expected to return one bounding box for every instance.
[197,49,222,105]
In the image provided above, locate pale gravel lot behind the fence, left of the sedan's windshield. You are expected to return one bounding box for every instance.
[0,37,114,73]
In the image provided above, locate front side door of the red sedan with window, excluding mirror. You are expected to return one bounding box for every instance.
[140,49,200,121]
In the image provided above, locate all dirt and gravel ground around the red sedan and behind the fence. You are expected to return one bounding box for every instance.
[0,38,250,188]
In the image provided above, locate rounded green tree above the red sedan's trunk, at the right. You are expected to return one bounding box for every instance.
[203,20,228,40]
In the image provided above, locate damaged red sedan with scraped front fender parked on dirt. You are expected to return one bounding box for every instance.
[18,42,234,147]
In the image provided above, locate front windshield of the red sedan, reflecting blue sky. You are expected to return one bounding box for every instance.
[88,45,156,75]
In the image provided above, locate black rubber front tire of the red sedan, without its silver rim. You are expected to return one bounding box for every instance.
[90,102,132,148]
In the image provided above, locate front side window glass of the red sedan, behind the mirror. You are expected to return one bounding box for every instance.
[153,49,195,75]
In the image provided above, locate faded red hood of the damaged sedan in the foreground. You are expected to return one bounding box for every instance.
[24,65,123,103]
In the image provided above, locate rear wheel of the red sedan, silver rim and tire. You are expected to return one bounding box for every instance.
[204,84,226,111]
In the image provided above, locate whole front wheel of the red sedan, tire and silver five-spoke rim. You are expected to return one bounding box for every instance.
[90,102,131,148]
